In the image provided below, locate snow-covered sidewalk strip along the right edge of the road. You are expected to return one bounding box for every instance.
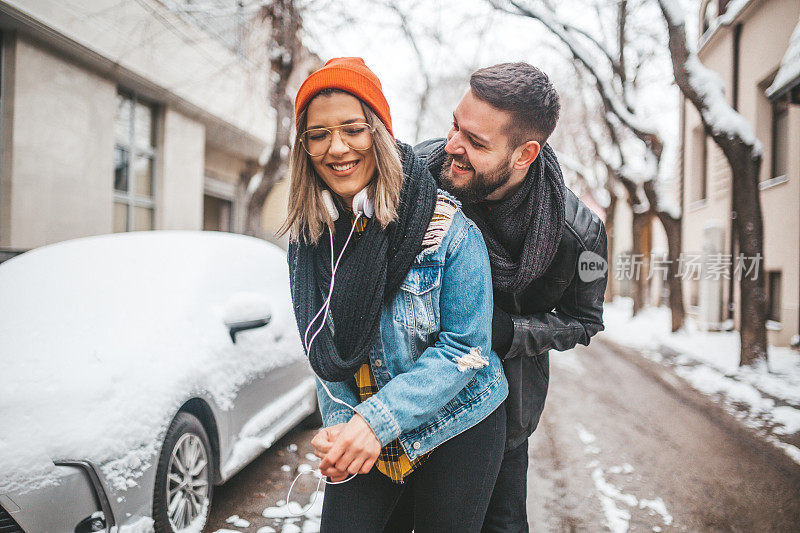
[601,298,800,465]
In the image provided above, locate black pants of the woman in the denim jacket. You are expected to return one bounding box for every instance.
[320,405,506,533]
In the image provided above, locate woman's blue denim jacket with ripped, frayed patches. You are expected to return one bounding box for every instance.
[317,192,508,460]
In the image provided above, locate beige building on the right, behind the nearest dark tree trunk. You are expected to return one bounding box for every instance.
[681,0,800,346]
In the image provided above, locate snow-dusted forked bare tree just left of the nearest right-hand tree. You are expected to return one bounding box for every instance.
[487,0,684,331]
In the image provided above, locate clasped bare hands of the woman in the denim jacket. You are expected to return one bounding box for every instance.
[311,414,381,482]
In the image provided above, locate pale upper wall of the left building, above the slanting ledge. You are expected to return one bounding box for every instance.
[7,0,272,143]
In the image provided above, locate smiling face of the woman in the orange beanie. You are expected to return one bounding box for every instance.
[306,92,377,208]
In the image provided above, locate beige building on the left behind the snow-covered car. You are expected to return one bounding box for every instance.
[0,0,285,260]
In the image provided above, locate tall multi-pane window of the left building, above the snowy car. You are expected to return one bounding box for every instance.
[114,92,156,232]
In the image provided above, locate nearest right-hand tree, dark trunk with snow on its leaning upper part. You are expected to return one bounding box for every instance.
[658,0,767,365]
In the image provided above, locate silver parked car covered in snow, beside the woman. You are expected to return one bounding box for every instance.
[0,231,318,533]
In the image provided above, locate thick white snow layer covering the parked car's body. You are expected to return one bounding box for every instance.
[0,231,303,493]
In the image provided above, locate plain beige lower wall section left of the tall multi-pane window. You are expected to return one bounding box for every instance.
[6,38,117,249]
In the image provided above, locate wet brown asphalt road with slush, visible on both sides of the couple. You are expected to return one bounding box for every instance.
[207,342,800,533]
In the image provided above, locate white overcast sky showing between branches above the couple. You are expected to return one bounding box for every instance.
[305,0,692,165]
